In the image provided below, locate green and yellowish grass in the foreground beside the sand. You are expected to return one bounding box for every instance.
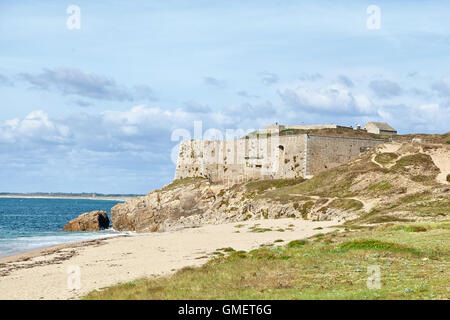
[84,222,450,300]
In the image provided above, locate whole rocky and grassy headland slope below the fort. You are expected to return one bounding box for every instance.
[111,144,450,232]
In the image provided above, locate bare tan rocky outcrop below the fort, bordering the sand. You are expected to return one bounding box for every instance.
[111,180,354,232]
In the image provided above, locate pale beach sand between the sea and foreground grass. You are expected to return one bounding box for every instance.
[0,219,338,299]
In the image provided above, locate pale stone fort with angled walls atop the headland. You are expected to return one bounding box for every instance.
[175,124,392,184]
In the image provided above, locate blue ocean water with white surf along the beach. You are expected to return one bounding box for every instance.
[0,198,130,257]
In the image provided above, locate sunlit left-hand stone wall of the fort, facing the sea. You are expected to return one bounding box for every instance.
[175,135,306,183]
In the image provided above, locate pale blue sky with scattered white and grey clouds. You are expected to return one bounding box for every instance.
[0,0,450,194]
